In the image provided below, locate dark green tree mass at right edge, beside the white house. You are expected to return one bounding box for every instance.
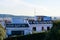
[45,22,60,40]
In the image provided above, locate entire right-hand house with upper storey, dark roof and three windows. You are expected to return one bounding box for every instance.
[27,16,53,34]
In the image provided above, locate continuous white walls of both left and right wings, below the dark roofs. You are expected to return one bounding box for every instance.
[6,24,53,35]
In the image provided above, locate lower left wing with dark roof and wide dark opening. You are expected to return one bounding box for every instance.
[6,23,30,36]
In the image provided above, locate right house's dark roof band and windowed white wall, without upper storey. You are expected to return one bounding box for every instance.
[28,20,53,34]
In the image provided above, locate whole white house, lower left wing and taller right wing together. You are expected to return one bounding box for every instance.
[5,16,53,37]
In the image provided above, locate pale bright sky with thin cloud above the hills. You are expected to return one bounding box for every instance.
[0,0,60,16]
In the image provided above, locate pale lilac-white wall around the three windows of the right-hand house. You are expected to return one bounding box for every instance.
[29,24,53,32]
